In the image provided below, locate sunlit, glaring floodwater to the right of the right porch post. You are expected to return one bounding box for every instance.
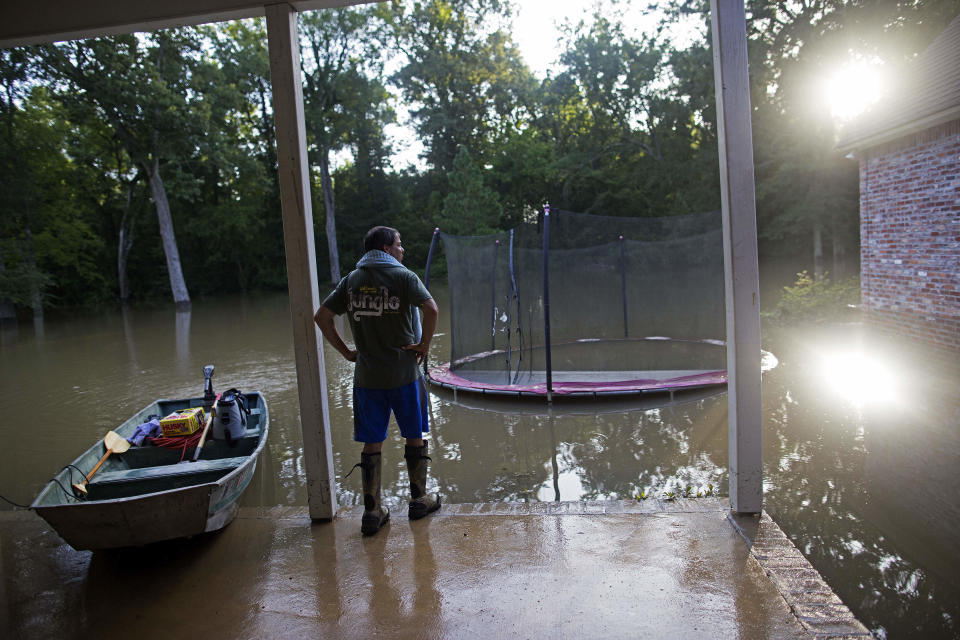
[764,327,960,638]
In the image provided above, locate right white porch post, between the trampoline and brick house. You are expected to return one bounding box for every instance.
[710,0,763,513]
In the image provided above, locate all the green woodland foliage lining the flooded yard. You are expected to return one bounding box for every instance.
[0,0,958,316]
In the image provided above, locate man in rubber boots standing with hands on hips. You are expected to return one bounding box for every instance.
[313,227,440,535]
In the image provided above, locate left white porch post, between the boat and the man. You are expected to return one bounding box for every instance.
[265,4,337,520]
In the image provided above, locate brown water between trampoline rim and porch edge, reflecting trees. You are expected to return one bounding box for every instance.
[418,384,727,503]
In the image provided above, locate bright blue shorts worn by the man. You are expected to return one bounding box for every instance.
[353,380,430,443]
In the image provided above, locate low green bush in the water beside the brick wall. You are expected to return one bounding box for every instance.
[764,271,860,324]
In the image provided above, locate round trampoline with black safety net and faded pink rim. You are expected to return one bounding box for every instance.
[424,207,727,401]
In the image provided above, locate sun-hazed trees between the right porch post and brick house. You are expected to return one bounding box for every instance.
[672,0,960,276]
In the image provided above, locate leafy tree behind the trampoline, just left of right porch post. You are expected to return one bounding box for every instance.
[539,11,719,216]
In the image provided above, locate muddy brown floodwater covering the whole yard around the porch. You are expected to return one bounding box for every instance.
[0,285,960,638]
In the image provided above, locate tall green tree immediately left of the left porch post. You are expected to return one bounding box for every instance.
[187,20,286,292]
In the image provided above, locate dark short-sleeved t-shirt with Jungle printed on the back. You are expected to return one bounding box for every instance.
[323,265,433,389]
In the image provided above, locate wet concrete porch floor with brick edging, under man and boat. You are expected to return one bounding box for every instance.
[0,499,869,640]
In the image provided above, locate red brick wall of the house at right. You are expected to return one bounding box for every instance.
[860,120,960,350]
